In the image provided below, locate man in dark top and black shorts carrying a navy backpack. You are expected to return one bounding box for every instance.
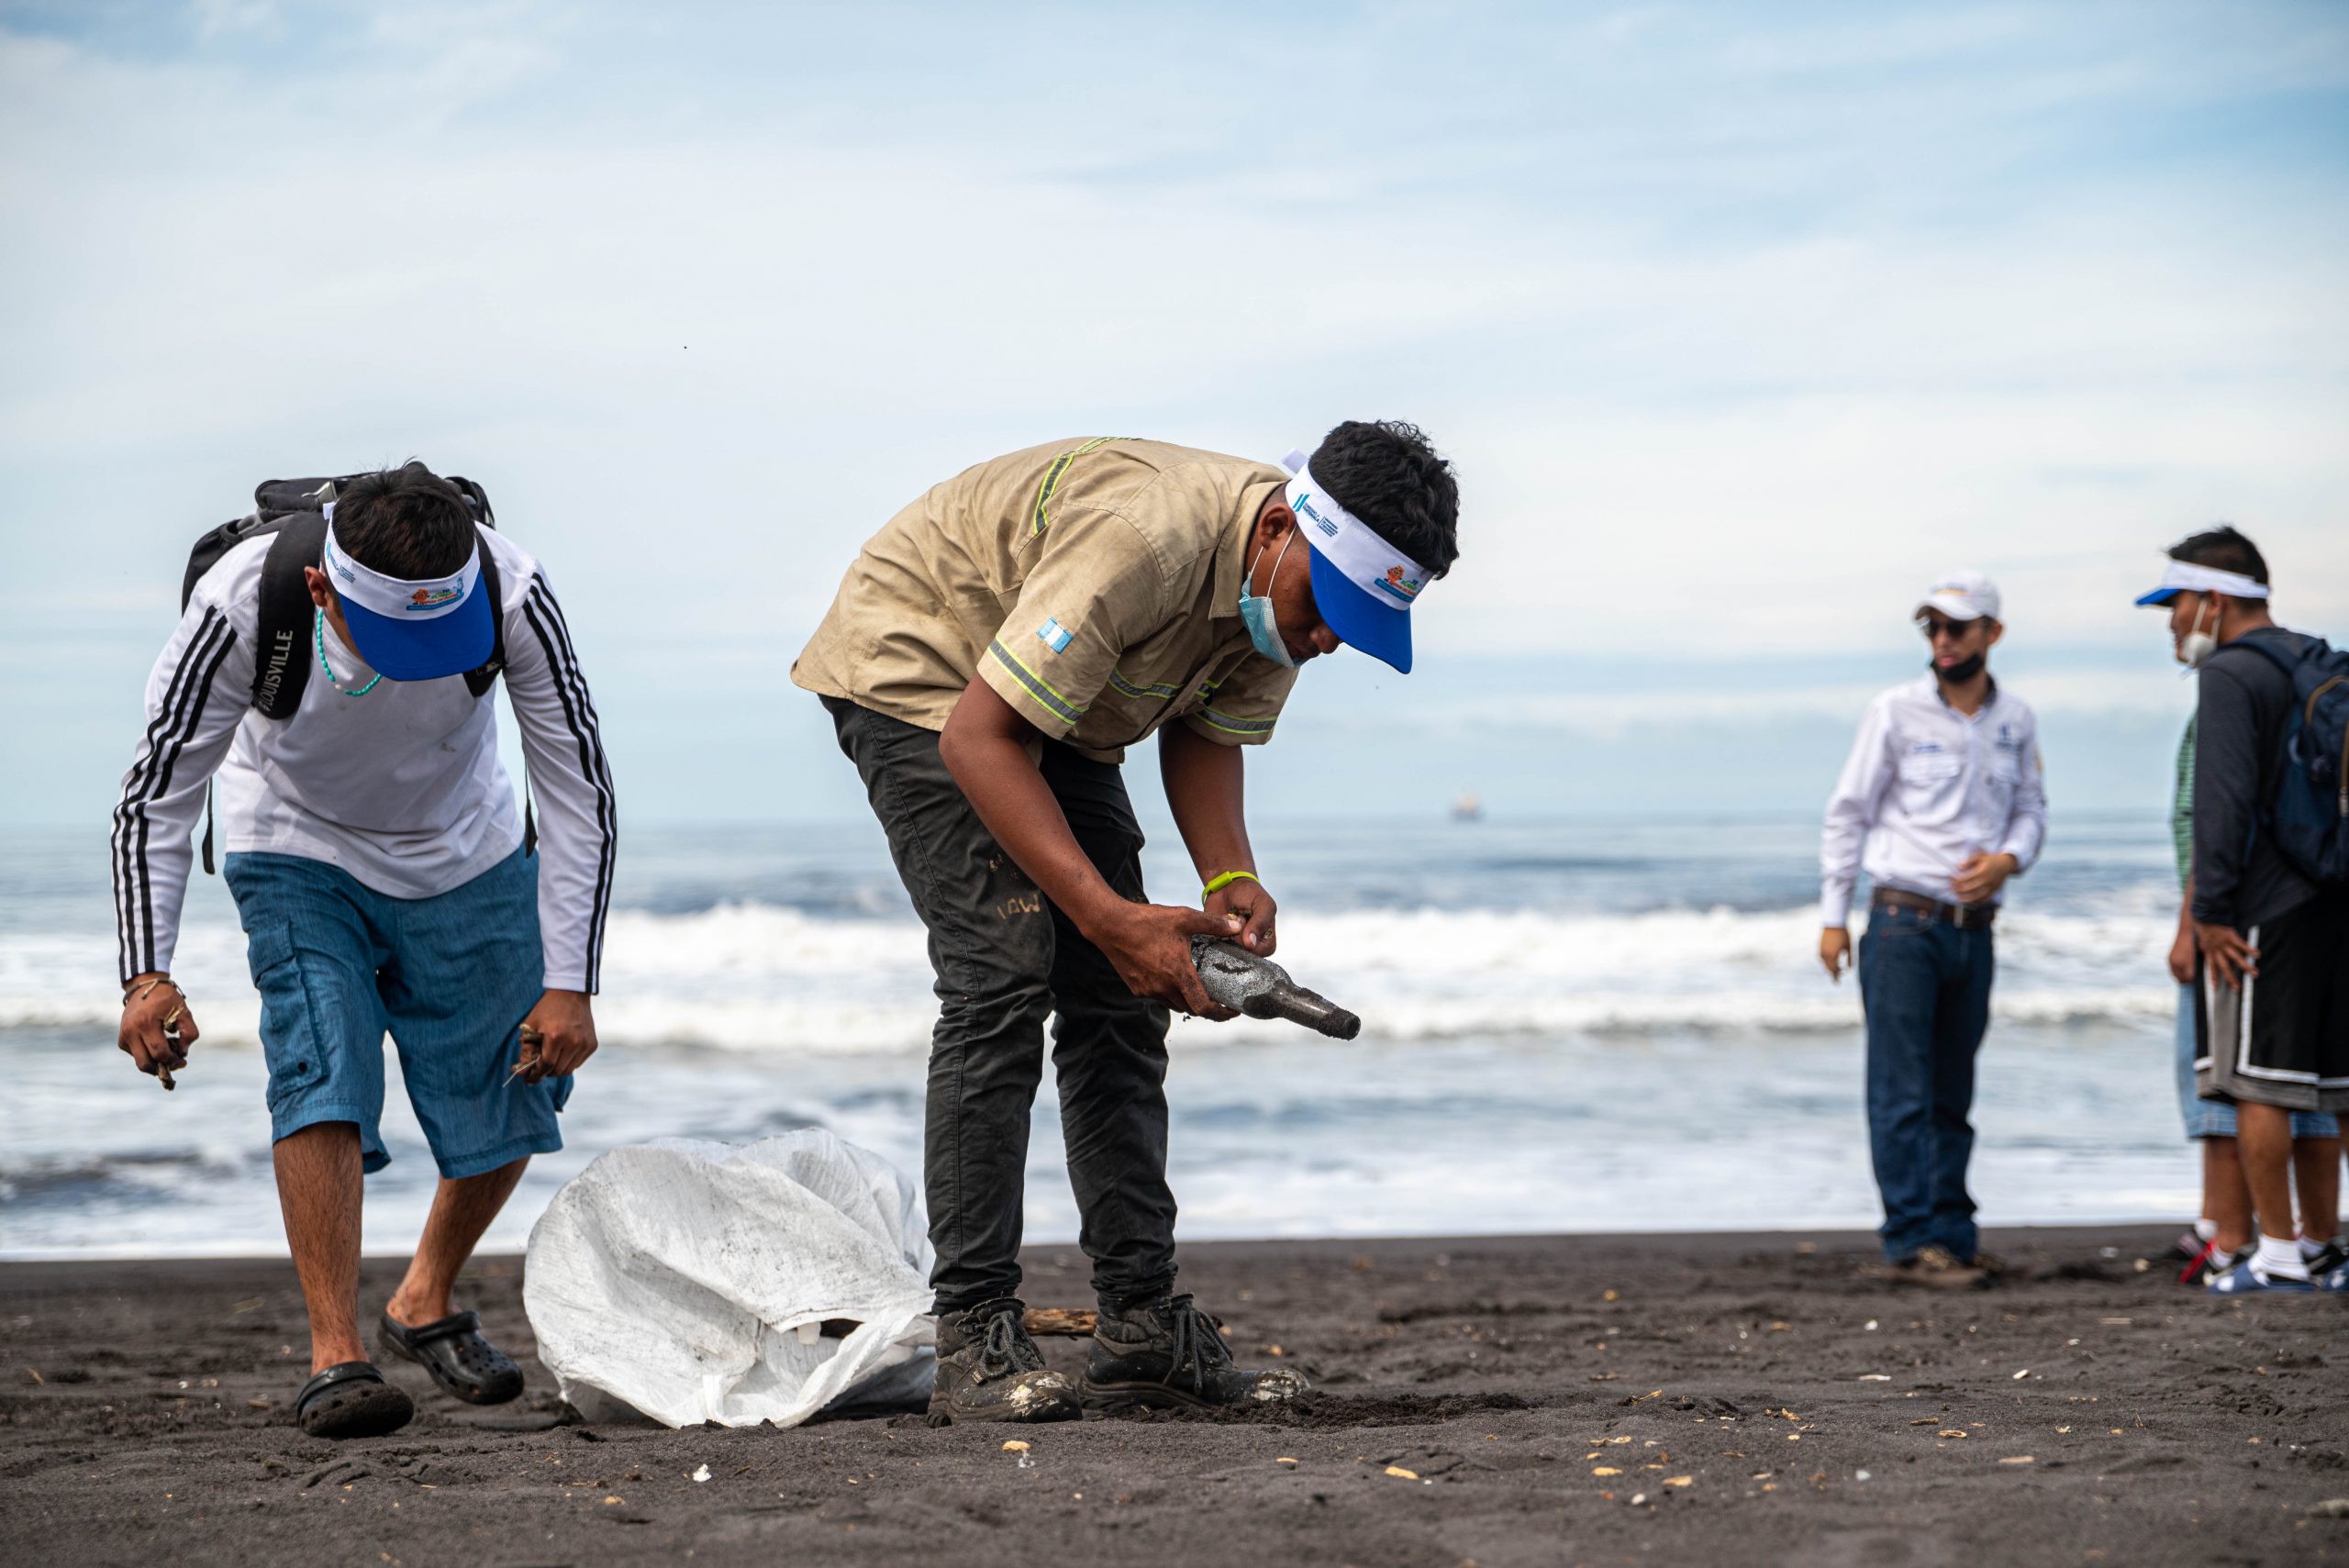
[2138,526,2349,1296]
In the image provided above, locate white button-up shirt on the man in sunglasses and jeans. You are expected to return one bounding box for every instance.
[1818,673,2048,928]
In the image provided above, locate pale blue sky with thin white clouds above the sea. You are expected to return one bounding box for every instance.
[0,0,2349,833]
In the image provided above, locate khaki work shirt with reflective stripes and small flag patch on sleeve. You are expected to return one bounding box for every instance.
[792,437,1297,761]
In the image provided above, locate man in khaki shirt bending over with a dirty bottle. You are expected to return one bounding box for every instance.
[792,420,1459,1422]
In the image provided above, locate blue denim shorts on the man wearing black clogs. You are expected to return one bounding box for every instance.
[226,850,571,1176]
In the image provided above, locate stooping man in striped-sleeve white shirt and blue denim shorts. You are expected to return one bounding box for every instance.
[113,462,616,1437]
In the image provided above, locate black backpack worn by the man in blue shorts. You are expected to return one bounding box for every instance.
[179,474,538,871]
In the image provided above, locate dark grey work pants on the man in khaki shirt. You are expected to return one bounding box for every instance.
[825,697,1174,1312]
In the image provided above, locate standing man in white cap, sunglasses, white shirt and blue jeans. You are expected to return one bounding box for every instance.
[1818,573,2046,1286]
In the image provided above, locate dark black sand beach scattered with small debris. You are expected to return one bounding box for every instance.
[0,1230,2349,1568]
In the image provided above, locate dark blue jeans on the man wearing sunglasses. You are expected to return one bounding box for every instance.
[1858,908,1997,1262]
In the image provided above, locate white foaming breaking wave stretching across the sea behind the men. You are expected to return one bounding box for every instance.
[0,904,2176,1054]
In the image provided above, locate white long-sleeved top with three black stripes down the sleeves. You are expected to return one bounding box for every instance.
[113,528,616,991]
